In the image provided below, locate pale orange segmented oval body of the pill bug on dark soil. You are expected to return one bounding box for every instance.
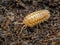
[23,10,50,27]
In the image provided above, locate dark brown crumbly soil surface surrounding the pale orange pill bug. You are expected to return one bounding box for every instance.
[0,0,60,45]
